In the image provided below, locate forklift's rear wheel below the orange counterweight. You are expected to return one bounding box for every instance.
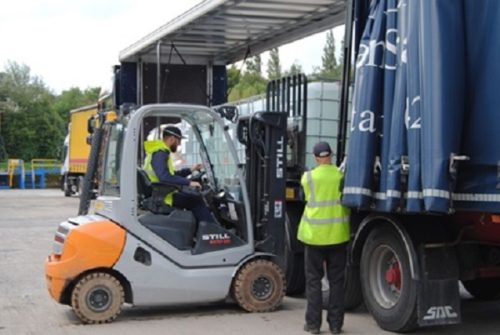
[71,272,125,324]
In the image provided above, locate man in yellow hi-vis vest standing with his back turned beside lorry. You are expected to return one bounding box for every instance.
[298,142,350,334]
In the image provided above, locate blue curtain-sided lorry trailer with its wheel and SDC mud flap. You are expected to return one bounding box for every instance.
[342,0,500,332]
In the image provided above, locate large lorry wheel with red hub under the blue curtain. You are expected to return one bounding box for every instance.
[360,226,417,332]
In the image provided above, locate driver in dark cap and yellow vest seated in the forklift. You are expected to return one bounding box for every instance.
[144,126,214,222]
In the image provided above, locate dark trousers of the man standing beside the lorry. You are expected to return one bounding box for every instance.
[304,243,347,328]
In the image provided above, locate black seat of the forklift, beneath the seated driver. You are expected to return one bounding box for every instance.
[137,168,176,214]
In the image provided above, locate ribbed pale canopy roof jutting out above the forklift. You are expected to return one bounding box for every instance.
[120,0,346,64]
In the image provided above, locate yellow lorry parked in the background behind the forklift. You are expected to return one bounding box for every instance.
[61,104,97,197]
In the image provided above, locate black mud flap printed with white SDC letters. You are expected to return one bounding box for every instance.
[418,246,462,326]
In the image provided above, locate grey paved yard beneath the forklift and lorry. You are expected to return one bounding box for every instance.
[0,190,500,335]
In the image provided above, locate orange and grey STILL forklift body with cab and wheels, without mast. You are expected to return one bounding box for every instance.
[46,104,286,323]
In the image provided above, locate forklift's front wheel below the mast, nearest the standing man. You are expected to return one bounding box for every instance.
[232,259,286,313]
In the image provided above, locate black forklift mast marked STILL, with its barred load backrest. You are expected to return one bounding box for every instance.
[237,75,307,263]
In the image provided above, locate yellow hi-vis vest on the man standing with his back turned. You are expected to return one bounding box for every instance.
[297,164,350,246]
